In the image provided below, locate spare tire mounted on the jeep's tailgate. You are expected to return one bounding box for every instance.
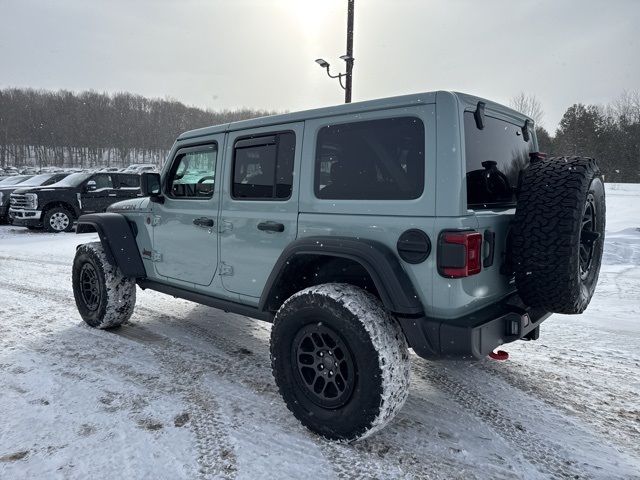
[510,157,605,314]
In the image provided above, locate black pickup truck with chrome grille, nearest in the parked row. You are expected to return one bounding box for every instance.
[9,172,141,232]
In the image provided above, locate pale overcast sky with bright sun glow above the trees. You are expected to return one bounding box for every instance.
[0,0,640,130]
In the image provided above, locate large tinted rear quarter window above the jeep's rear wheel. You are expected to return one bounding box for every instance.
[314,117,425,200]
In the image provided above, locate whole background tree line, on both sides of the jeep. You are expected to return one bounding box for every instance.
[0,88,640,183]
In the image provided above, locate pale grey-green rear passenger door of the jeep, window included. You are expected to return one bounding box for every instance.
[219,123,304,298]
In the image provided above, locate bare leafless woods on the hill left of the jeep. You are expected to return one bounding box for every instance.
[0,88,274,168]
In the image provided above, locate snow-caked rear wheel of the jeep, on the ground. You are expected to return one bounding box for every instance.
[271,283,410,441]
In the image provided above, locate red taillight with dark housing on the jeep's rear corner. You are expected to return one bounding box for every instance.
[438,231,482,278]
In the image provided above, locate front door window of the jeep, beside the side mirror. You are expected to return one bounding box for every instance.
[167,144,218,198]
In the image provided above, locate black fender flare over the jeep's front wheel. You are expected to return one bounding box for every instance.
[76,212,147,278]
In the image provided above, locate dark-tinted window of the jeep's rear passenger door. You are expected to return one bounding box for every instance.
[231,132,296,200]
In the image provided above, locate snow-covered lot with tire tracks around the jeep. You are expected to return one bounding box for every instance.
[0,184,640,479]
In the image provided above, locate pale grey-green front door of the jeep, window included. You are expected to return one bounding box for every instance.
[152,141,224,285]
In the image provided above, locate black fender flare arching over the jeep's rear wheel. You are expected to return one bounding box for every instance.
[258,236,424,316]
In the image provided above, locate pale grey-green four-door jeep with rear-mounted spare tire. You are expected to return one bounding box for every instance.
[73,91,605,441]
